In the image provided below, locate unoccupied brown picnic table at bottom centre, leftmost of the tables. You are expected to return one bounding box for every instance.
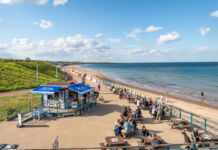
[105,136,126,147]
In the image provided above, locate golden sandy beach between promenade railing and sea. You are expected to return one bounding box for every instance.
[68,65,218,123]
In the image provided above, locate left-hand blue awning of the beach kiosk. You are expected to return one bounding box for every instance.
[31,86,62,95]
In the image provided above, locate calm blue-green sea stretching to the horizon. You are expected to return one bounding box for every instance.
[79,62,218,106]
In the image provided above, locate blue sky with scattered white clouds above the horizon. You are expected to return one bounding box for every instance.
[0,0,218,62]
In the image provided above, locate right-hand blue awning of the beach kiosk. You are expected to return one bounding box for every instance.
[68,83,92,94]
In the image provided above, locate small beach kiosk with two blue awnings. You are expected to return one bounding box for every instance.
[31,83,97,117]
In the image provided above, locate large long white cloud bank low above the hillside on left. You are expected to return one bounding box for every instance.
[0,34,110,61]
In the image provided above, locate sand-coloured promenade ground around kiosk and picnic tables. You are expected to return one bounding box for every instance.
[0,67,190,149]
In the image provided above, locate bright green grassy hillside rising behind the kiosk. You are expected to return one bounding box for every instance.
[0,59,63,92]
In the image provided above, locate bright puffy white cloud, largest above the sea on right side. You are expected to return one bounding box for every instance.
[157,31,180,44]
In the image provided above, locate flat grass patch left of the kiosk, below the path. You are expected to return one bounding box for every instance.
[0,94,41,121]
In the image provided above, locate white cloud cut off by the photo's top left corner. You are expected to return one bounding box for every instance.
[0,0,49,5]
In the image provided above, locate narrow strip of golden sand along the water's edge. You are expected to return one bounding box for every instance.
[71,65,218,123]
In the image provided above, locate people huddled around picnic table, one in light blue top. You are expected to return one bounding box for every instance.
[113,107,141,138]
